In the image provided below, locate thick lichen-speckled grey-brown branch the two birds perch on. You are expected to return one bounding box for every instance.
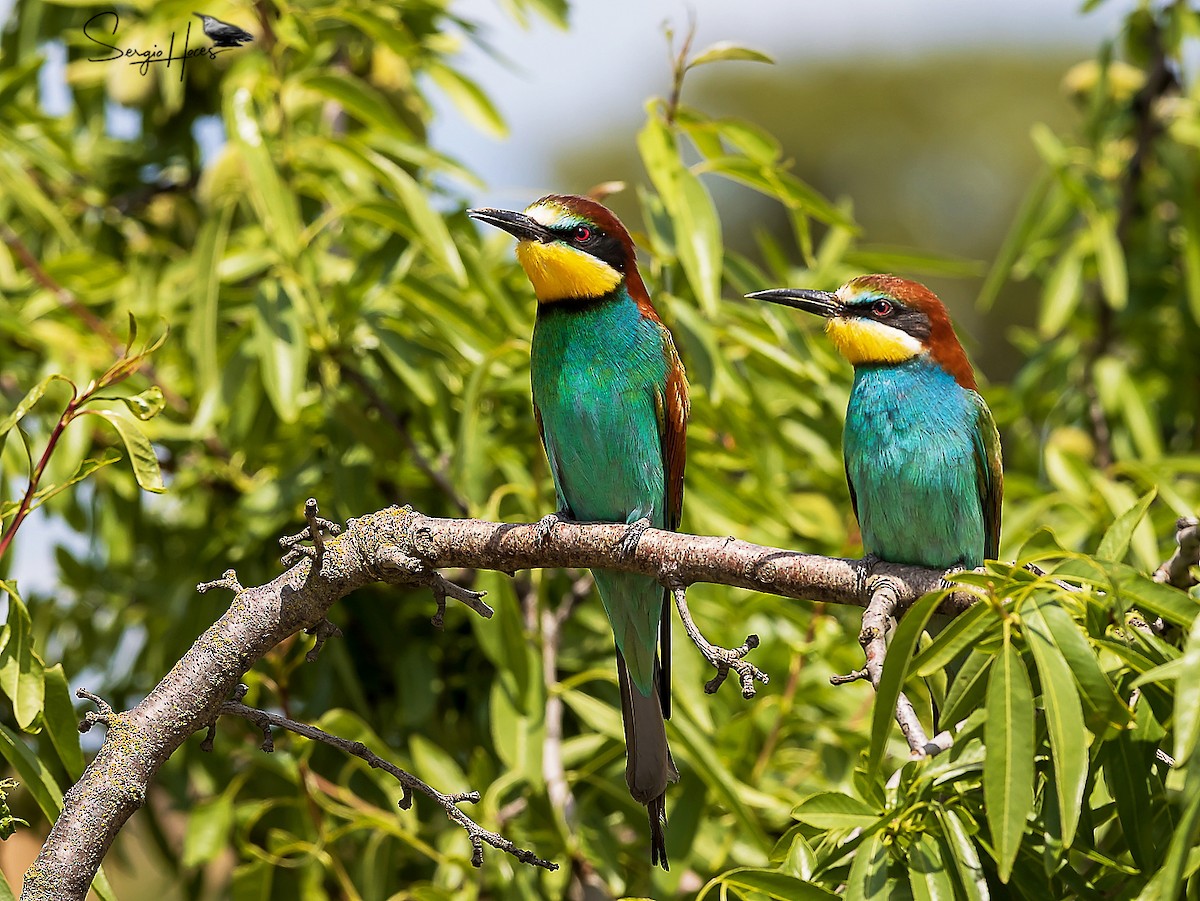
[22,507,973,901]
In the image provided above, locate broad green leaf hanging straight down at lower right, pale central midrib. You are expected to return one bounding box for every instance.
[983,636,1033,883]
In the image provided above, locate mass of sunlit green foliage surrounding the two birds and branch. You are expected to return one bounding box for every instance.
[0,0,1200,899]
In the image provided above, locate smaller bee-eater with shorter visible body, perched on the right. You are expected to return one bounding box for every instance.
[748,275,1003,569]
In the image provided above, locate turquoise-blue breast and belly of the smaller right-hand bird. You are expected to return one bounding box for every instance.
[844,356,985,569]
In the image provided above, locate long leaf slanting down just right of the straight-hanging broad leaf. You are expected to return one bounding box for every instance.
[1022,605,1087,848]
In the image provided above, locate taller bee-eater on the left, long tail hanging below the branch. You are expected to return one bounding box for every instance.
[468,194,688,870]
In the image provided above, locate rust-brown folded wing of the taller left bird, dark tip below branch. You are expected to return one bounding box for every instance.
[654,323,690,720]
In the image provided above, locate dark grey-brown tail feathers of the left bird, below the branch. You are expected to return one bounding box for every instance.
[617,651,679,870]
